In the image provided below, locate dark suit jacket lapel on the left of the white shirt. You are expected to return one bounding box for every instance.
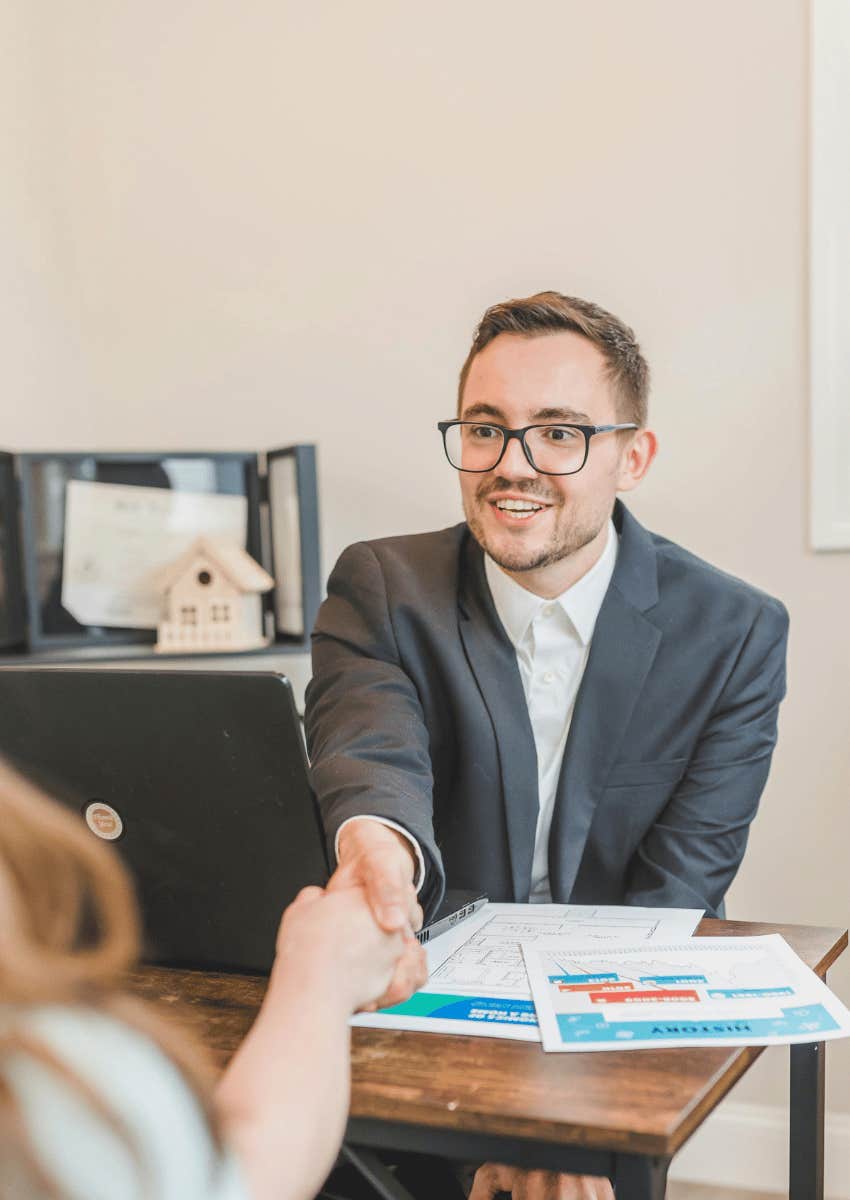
[457,535,539,901]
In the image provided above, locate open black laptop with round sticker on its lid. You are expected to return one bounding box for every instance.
[0,667,484,971]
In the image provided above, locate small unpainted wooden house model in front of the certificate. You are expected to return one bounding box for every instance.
[154,538,275,654]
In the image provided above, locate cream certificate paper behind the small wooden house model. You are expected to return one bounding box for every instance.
[62,479,247,629]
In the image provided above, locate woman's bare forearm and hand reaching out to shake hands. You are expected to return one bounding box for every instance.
[216,888,425,1200]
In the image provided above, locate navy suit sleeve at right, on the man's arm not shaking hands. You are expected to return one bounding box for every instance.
[627,601,788,917]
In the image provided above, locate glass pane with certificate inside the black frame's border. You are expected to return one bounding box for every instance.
[17,451,262,649]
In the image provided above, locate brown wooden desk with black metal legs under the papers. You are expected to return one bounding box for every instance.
[133,920,848,1200]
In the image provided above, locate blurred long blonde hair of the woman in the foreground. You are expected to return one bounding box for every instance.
[0,762,215,1198]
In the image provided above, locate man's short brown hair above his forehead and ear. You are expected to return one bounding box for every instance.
[457,292,650,425]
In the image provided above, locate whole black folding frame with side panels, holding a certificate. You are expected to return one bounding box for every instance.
[0,444,321,659]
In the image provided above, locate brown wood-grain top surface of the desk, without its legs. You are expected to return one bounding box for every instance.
[132,919,848,1157]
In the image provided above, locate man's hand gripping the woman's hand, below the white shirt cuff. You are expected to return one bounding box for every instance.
[328,820,427,1009]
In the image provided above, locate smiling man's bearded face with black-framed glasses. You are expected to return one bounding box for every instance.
[439,328,638,598]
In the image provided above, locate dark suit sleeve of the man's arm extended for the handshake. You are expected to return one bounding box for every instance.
[305,544,444,919]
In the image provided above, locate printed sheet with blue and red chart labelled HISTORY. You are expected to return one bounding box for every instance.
[522,934,850,1051]
